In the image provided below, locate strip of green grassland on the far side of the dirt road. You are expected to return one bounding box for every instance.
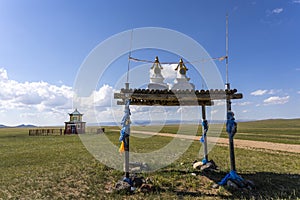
[133,119,300,144]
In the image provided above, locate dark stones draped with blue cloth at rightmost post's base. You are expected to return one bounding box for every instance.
[218,170,254,190]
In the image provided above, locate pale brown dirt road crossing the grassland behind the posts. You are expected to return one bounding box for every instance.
[127,130,300,153]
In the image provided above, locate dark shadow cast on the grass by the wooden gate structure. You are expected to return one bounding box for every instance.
[158,170,300,199]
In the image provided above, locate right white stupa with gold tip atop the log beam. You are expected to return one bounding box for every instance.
[172,58,195,90]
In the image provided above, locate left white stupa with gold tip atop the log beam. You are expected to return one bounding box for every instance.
[148,56,169,90]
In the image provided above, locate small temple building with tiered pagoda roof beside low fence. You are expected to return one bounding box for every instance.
[64,108,86,134]
